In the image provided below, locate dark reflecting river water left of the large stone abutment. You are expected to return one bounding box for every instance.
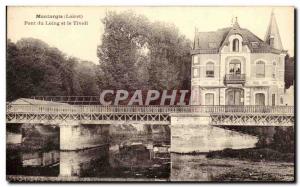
[7,125,170,179]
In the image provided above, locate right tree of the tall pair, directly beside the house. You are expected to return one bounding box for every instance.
[149,22,191,90]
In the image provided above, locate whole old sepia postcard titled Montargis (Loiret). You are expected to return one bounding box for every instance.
[6,6,295,182]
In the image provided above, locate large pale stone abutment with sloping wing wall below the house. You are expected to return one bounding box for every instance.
[171,113,258,153]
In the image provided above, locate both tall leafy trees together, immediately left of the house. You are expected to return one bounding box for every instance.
[98,12,191,90]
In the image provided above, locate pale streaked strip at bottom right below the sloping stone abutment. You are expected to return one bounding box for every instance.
[170,154,294,182]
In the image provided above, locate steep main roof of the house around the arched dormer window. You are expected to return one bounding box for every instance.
[192,18,282,54]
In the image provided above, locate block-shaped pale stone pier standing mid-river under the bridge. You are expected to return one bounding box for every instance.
[59,123,109,151]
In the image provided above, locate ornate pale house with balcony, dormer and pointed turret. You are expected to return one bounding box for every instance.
[191,13,286,106]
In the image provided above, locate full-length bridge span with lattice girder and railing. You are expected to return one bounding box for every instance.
[6,103,294,126]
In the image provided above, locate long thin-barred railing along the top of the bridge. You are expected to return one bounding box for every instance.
[6,103,294,114]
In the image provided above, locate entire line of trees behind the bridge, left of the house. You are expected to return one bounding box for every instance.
[6,12,191,101]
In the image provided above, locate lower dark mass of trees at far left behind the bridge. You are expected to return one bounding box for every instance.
[6,38,99,101]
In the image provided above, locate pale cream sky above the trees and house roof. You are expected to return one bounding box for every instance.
[7,6,294,63]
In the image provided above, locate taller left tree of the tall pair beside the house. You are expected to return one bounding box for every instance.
[97,12,146,90]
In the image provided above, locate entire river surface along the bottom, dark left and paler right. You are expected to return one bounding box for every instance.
[6,124,294,181]
